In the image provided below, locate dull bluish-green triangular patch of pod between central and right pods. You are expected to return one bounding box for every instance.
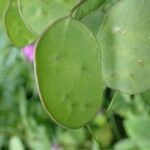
[81,8,105,36]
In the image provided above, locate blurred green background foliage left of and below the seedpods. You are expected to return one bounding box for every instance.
[0,0,150,150]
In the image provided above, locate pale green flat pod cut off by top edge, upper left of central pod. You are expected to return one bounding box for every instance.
[18,0,79,35]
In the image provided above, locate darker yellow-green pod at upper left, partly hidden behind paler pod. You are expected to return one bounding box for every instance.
[5,0,35,47]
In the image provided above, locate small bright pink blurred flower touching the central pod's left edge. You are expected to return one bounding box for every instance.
[23,44,35,62]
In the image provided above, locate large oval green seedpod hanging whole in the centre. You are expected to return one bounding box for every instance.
[34,18,102,129]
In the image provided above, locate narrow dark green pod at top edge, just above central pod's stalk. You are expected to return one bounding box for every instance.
[75,0,106,20]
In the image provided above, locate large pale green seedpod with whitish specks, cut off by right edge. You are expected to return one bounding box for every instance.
[97,0,150,94]
